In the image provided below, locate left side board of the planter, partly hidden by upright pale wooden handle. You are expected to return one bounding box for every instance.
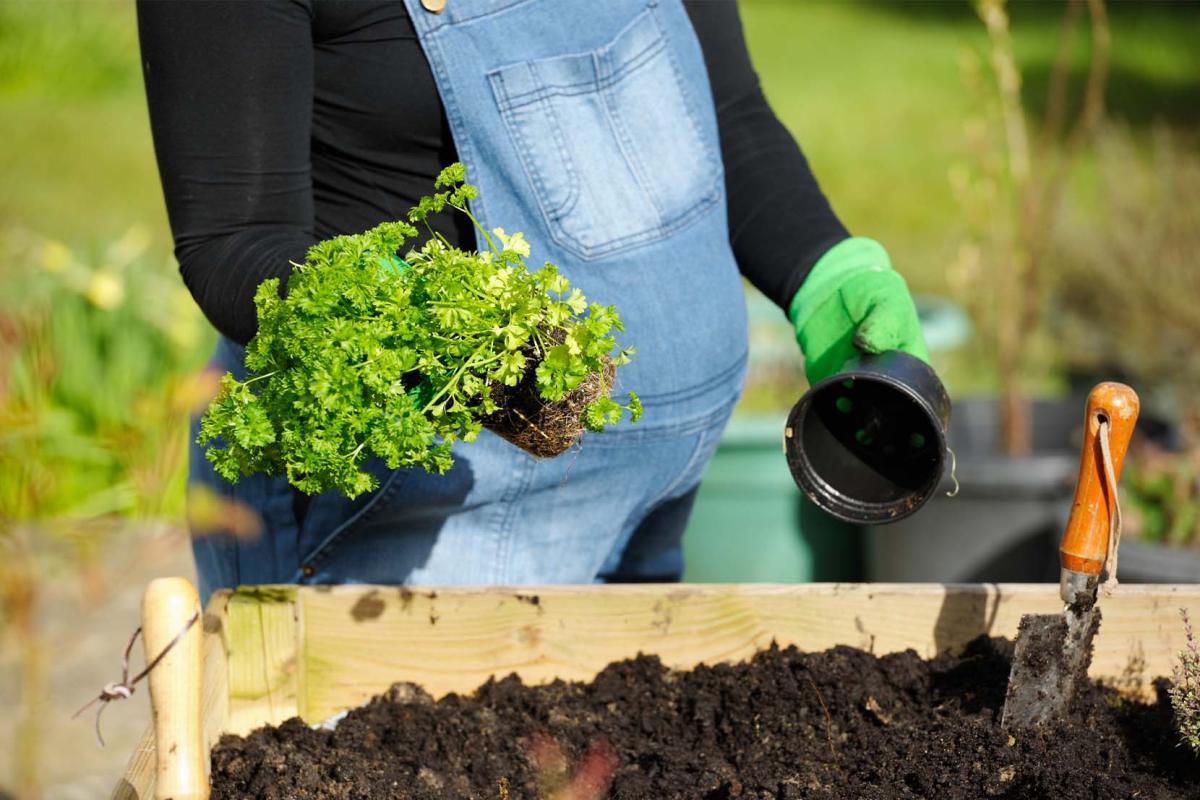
[112,593,229,800]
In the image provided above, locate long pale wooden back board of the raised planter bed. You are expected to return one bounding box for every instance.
[296,584,1200,722]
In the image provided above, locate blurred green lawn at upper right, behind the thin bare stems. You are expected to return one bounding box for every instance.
[742,0,1200,293]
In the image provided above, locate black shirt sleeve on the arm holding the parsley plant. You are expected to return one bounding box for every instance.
[137,0,316,344]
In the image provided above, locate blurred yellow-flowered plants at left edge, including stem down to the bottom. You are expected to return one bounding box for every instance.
[0,227,211,796]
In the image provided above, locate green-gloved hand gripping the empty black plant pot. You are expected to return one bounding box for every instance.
[787,236,929,385]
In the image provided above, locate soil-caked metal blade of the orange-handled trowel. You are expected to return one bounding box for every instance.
[1002,606,1100,729]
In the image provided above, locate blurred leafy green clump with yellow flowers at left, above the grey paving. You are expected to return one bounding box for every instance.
[0,228,208,528]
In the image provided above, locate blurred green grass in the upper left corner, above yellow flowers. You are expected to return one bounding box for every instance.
[0,0,169,253]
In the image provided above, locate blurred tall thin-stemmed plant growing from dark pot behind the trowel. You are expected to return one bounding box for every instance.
[949,0,1110,456]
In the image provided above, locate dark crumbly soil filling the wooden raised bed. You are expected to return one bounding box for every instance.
[212,638,1200,800]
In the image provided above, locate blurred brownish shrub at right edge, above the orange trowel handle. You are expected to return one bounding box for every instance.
[1052,126,1200,413]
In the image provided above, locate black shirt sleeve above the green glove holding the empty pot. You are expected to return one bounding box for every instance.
[684,0,850,312]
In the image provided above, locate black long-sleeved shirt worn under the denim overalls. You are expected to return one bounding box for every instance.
[137,0,847,343]
